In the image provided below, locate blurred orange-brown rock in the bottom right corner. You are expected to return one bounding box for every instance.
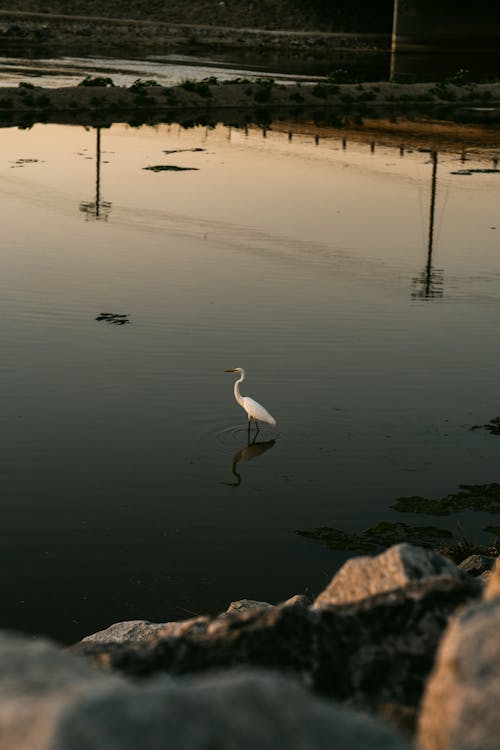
[418,596,500,750]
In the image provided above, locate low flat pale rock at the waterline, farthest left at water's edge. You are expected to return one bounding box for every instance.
[83,617,210,644]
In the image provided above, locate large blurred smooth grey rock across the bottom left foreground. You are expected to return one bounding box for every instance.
[0,637,410,750]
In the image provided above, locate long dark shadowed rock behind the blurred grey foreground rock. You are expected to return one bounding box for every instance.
[73,574,482,724]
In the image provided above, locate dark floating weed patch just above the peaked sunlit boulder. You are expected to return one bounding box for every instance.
[295,521,453,552]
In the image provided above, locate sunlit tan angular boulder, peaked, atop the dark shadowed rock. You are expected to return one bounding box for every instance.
[313,543,464,608]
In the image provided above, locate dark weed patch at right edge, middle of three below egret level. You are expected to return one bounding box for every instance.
[391,482,500,516]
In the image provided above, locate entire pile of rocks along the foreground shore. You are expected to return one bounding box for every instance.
[0,543,500,750]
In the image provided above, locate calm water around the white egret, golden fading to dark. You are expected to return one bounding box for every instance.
[0,120,500,641]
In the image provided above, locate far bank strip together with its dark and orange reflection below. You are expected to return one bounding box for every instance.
[0,78,500,148]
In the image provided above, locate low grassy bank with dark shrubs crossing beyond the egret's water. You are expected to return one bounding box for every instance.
[0,78,500,121]
